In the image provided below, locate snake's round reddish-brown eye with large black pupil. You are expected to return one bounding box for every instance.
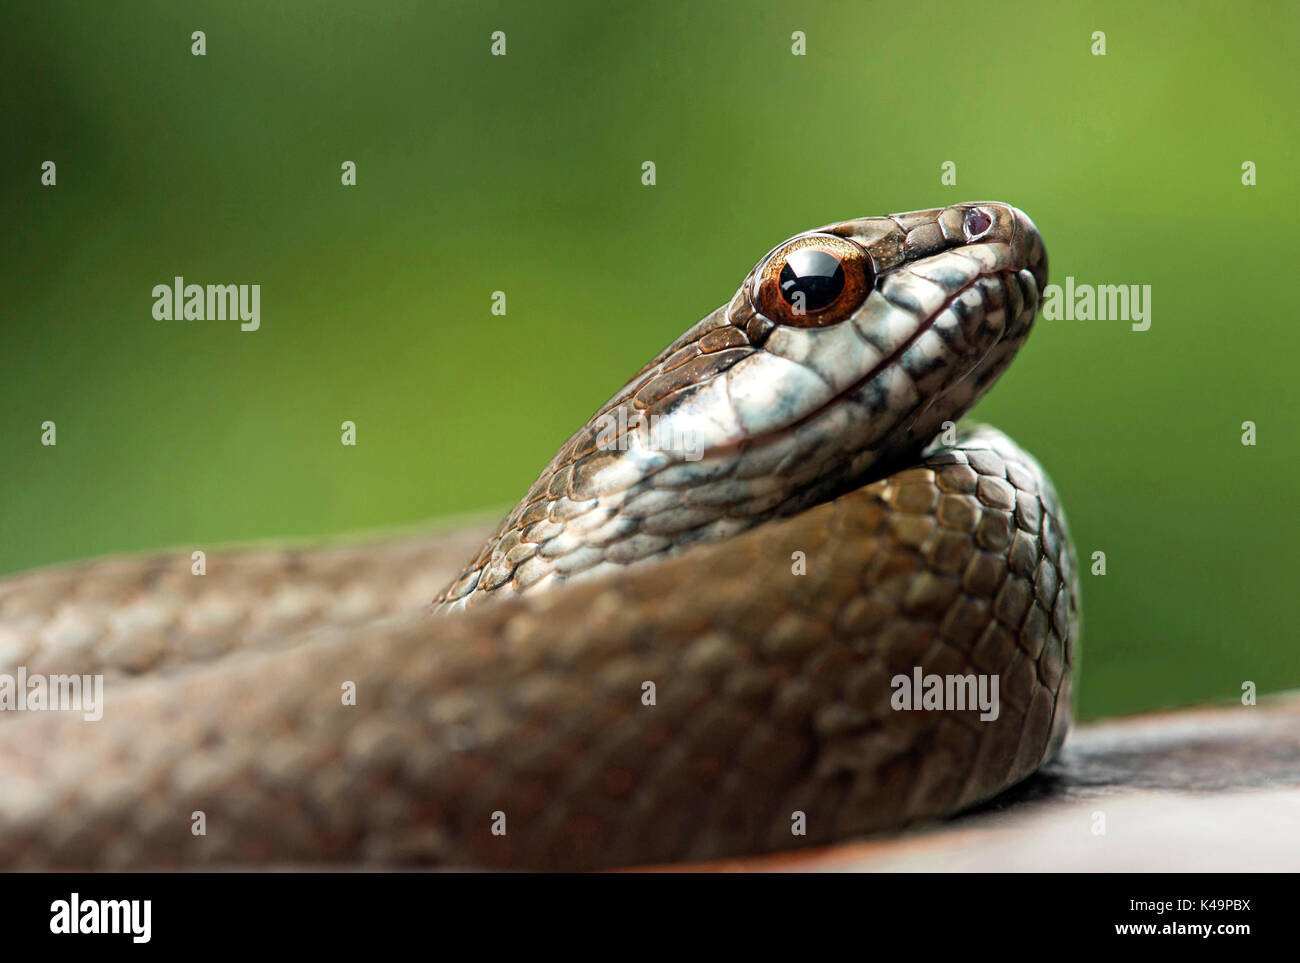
[753,234,875,327]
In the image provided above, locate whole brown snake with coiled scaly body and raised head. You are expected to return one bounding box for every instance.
[0,201,1079,871]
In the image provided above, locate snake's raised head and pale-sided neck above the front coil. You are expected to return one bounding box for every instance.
[439,201,1047,603]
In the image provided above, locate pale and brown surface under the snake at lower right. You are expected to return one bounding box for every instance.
[676,693,1300,872]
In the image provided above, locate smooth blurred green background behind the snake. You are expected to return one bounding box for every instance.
[0,0,1300,716]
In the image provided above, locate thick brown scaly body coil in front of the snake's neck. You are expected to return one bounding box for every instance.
[0,429,1078,869]
